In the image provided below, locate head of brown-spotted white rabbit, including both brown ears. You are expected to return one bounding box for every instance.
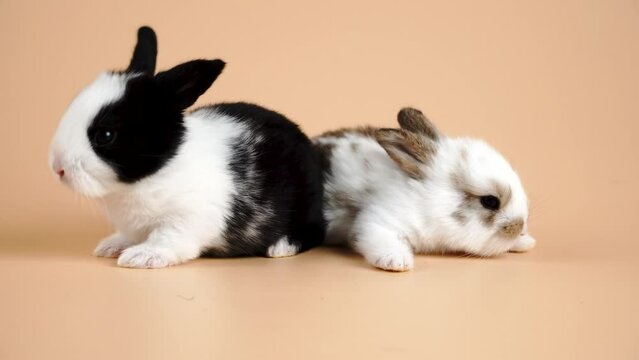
[376,108,535,256]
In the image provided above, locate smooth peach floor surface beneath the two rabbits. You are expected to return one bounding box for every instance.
[0,224,639,359]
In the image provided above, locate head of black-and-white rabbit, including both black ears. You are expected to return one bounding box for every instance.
[49,27,225,197]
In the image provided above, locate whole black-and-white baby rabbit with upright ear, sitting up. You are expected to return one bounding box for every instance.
[50,27,326,268]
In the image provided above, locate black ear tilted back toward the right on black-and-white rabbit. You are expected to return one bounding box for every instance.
[155,59,226,110]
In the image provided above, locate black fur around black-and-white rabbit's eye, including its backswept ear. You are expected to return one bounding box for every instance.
[87,60,225,183]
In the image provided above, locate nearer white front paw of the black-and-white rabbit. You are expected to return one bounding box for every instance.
[118,244,179,269]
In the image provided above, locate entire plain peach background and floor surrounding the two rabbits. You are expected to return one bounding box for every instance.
[0,0,639,359]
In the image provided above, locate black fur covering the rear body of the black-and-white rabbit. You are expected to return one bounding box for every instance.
[202,103,326,256]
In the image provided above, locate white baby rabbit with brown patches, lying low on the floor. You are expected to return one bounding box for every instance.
[314,108,535,271]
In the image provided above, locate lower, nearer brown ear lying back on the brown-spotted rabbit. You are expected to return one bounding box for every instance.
[375,129,436,179]
